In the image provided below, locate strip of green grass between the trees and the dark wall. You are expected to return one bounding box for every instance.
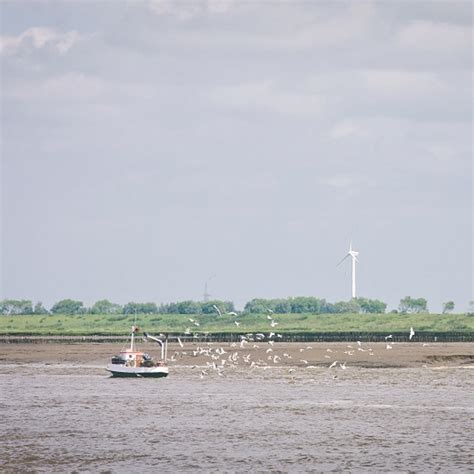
[0,313,474,336]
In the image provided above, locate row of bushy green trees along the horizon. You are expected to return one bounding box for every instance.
[0,296,462,315]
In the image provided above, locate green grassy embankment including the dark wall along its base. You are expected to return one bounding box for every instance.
[0,313,474,343]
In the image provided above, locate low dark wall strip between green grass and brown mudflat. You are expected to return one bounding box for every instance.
[0,332,474,344]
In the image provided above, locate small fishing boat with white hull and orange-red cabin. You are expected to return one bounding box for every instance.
[107,326,168,377]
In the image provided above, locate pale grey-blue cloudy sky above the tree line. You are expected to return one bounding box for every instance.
[0,0,474,312]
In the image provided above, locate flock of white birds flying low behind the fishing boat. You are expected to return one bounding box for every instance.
[146,305,415,379]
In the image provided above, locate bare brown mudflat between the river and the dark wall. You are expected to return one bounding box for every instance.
[0,342,474,368]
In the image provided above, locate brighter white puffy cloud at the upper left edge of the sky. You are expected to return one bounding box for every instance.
[0,27,80,56]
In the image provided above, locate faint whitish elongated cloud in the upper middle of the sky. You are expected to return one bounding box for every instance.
[211,81,325,117]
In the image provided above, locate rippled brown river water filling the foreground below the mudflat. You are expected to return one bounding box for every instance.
[0,344,474,473]
